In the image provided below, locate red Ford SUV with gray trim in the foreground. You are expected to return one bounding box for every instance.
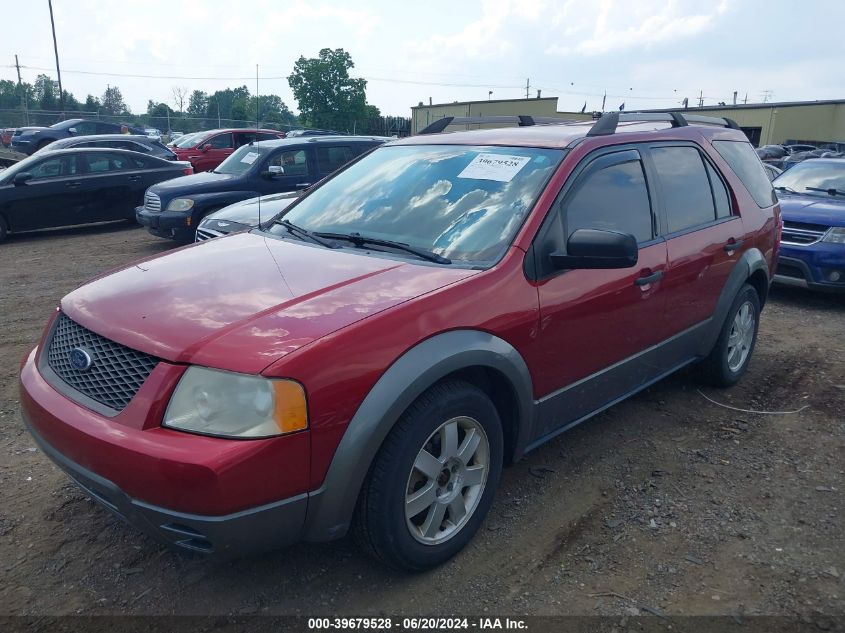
[21,113,781,570]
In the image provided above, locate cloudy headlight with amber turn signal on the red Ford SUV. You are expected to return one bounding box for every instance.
[162,366,308,438]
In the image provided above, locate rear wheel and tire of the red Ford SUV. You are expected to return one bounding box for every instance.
[701,284,760,387]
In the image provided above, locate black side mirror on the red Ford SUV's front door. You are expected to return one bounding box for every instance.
[549,229,638,270]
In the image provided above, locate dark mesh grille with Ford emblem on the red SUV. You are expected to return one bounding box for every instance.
[47,314,158,411]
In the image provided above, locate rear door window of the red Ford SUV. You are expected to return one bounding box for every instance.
[651,147,716,233]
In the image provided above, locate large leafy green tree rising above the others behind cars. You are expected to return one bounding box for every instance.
[288,48,367,130]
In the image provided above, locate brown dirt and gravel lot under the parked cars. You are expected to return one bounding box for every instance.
[0,225,845,619]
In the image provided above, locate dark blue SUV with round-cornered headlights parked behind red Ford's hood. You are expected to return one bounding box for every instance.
[135,136,389,242]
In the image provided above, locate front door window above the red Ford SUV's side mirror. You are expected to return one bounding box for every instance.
[564,160,653,242]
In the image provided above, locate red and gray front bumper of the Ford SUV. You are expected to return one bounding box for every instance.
[20,351,313,556]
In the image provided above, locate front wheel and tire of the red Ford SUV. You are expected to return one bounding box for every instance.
[354,380,503,571]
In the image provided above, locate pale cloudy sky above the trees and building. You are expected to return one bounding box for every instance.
[0,0,845,116]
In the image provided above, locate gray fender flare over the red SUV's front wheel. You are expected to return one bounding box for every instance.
[303,330,534,541]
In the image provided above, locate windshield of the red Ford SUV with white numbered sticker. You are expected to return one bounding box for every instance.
[270,145,564,266]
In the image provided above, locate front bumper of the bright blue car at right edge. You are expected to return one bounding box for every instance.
[774,242,845,292]
